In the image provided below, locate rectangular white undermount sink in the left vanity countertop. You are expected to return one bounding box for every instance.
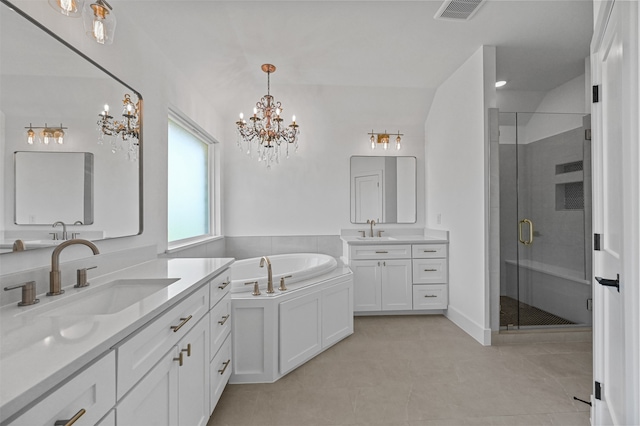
[39,278,179,317]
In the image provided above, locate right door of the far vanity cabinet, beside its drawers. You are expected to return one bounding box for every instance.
[381,259,413,311]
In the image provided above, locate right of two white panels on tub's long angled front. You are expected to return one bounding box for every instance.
[322,280,353,349]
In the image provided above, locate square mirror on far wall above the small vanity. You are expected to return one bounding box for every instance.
[351,156,417,223]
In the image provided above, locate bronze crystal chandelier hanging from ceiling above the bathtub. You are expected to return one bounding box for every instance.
[236,64,300,169]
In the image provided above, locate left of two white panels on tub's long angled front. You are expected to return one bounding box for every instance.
[279,291,322,374]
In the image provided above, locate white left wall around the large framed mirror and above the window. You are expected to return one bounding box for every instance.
[0,0,224,274]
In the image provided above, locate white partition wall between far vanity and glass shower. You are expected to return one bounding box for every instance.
[425,46,496,344]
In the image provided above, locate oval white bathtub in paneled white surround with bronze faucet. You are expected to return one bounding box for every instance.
[229,253,353,383]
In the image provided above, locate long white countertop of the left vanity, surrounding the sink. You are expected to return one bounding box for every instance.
[0,258,234,422]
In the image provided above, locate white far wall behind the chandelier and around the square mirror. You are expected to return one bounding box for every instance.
[224,86,425,236]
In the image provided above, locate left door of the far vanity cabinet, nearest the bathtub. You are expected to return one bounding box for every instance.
[350,260,382,312]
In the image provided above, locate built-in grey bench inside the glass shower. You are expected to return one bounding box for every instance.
[505,259,592,326]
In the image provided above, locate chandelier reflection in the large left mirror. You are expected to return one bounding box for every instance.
[97,93,140,161]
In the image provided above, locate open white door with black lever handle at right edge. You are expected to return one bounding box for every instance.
[592,1,640,425]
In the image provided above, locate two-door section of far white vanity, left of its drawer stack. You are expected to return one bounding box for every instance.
[349,245,413,312]
